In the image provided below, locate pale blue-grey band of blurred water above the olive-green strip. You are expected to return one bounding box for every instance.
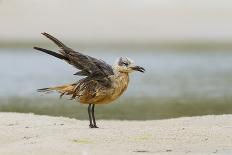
[0,50,232,97]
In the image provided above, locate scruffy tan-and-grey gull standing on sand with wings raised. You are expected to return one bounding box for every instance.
[34,32,145,128]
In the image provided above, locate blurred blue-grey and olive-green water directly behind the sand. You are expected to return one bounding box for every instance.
[0,49,232,119]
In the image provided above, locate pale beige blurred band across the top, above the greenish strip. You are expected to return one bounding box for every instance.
[0,0,232,42]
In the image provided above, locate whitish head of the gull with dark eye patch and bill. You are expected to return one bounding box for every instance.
[116,57,145,73]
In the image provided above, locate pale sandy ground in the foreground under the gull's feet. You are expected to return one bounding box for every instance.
[0,113,232,155]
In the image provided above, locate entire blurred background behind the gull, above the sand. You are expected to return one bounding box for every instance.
[0,0,232,120]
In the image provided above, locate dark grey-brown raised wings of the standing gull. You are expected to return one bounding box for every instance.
[34,32,114,85]
